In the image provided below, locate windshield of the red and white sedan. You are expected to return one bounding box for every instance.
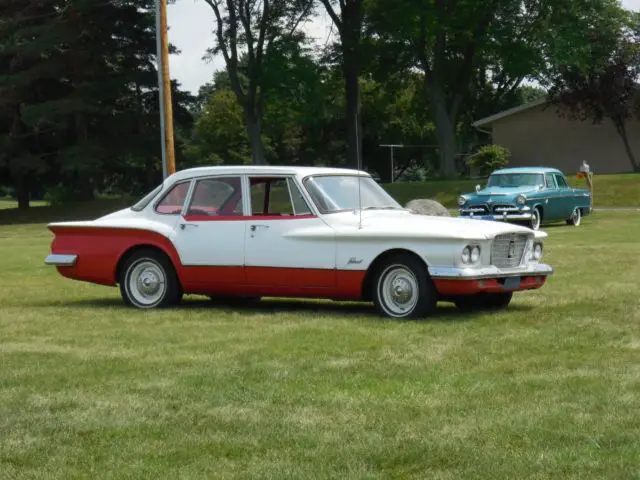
[303,175,402,213]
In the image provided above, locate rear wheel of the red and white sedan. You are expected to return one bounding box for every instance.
[119,250,182,309]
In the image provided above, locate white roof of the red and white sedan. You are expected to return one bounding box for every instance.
[167,165,369,181]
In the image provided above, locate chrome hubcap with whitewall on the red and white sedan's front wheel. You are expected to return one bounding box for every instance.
[379,265,419,316]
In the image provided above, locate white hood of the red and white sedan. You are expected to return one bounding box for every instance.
[324,210,547,240]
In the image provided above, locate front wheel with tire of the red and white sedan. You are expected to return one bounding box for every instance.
[373,253,438,318]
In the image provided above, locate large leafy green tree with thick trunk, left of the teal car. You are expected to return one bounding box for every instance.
[371,0,628,176]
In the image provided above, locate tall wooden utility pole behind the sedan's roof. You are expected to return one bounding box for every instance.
[155,0,176,179]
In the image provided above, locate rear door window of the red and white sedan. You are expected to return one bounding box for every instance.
[187,177,242,216]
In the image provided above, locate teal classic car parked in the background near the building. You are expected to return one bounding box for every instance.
[458,167,593,230]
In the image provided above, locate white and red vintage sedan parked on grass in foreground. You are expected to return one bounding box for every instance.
[45,166,553,318]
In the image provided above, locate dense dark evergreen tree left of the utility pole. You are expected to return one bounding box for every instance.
[0,0,192,207]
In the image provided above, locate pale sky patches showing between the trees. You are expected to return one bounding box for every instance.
[167,0,640,94]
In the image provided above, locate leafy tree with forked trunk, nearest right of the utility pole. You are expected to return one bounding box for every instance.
[205,0,313,164]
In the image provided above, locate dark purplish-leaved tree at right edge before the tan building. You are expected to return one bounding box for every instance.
[549,14,640,172]
